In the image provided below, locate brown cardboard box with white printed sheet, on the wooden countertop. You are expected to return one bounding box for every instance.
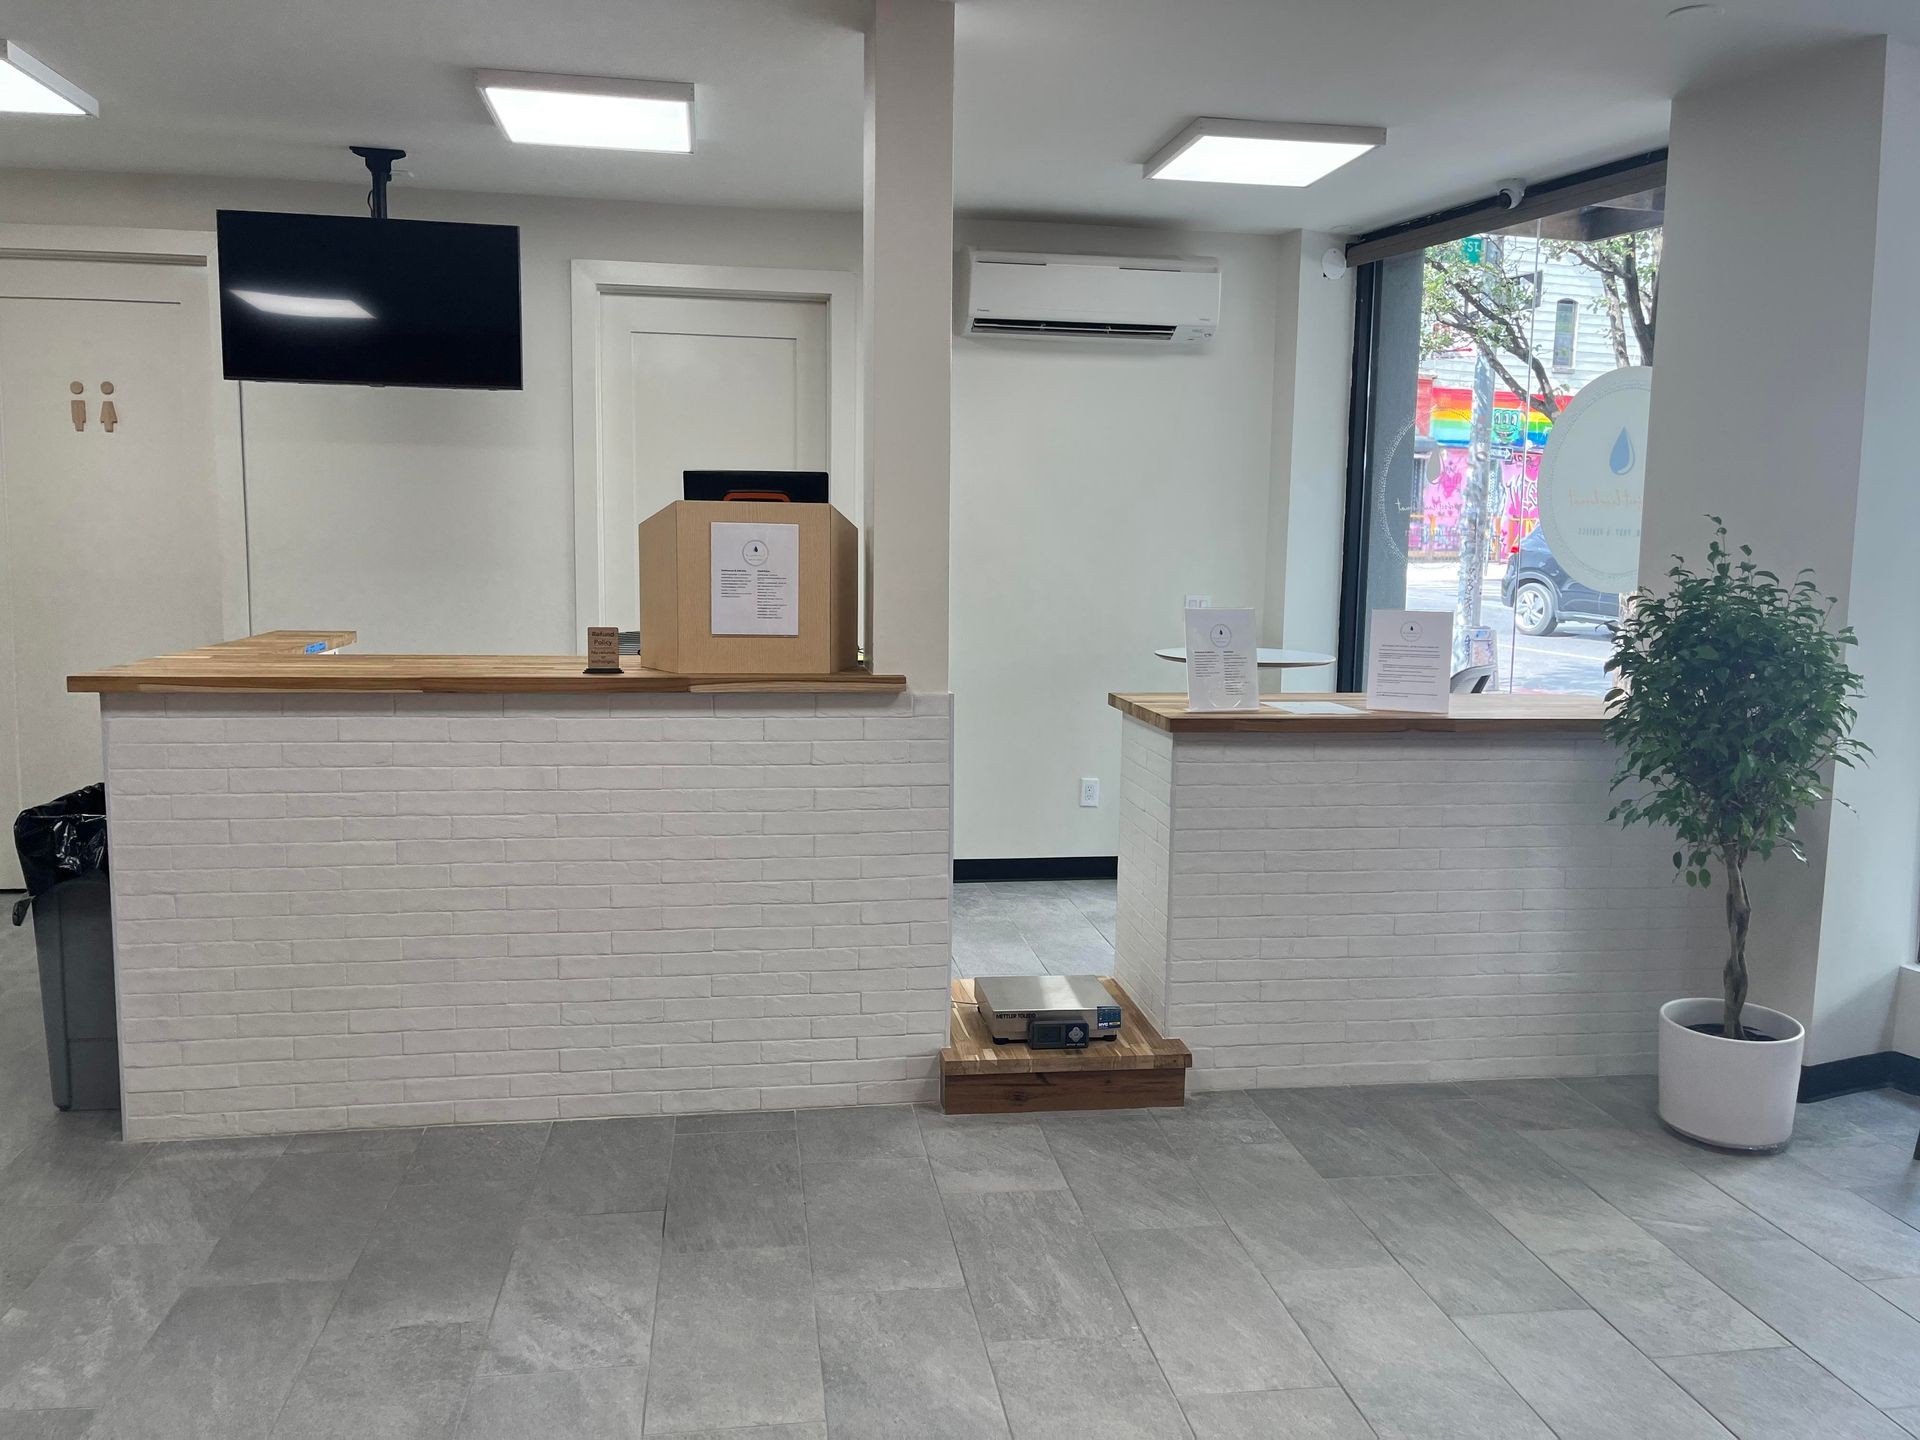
[639,499,860,676]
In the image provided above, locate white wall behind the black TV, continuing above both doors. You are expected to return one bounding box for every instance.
[0,171,860,653]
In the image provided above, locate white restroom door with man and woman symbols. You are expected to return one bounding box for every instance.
[0,259,221,887]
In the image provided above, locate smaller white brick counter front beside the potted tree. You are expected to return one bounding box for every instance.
[1116,718,1720,1089]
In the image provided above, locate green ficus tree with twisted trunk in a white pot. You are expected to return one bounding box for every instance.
[1607,515,1868,1041]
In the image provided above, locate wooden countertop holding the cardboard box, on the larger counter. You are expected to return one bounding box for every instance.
[67,630,906,695]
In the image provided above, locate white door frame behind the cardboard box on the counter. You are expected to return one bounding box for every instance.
[572,259,860,629]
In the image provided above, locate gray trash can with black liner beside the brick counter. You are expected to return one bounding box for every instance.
[13,785,119,1110]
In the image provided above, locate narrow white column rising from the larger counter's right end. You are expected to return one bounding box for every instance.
[862,0,954,691]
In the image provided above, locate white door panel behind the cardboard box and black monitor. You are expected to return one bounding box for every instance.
[597,294,829,630]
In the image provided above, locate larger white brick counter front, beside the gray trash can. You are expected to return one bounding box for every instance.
[102,691,952,1140]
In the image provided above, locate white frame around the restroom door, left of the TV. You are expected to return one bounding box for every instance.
[0,225,253,637]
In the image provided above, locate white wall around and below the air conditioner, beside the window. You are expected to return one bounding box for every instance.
[952,221,1352,858]
